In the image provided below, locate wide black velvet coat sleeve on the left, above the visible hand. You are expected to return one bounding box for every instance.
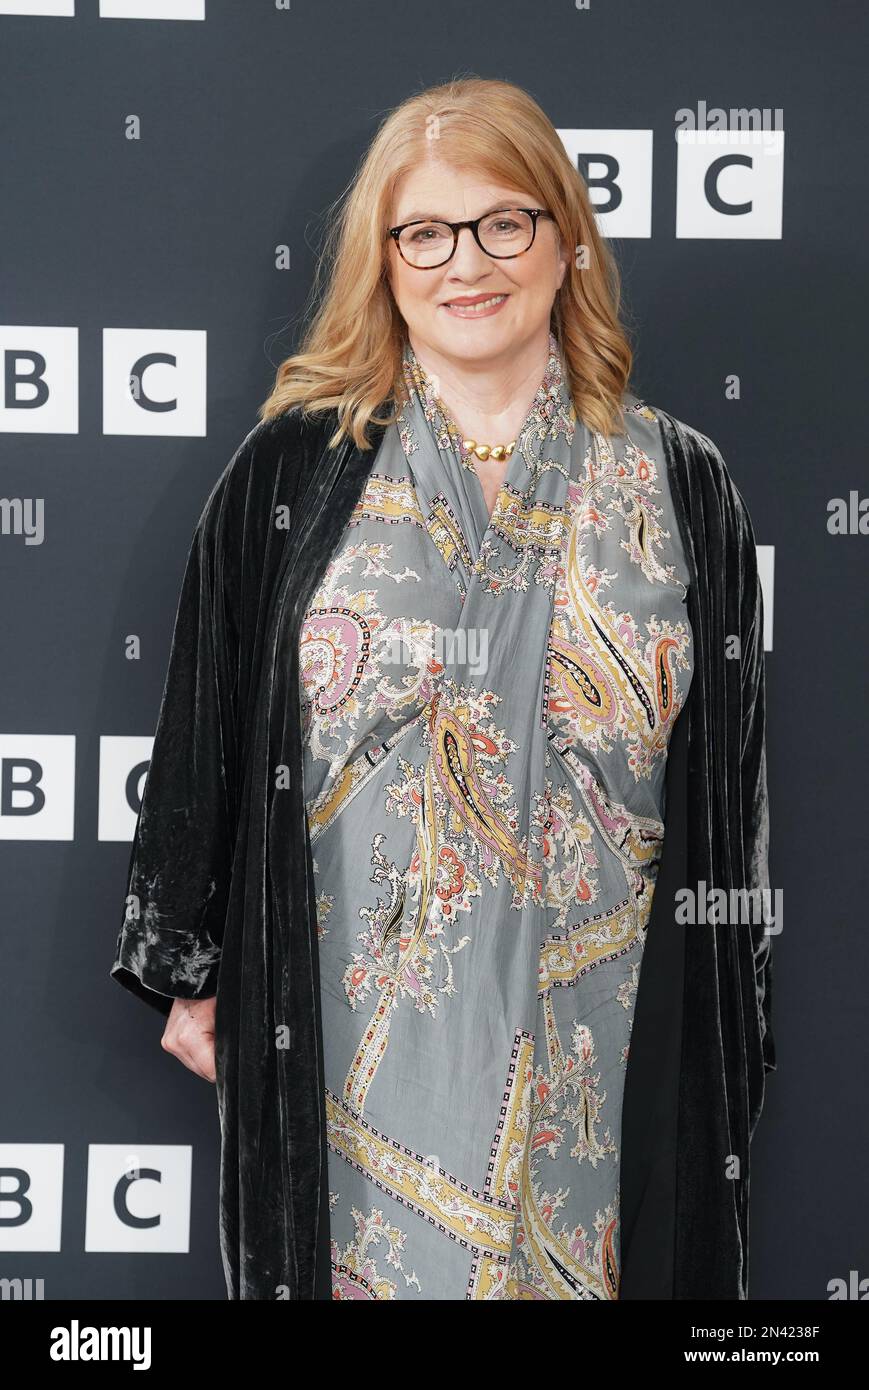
[110,446,243,1013]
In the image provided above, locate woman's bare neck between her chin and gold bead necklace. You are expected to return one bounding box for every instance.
[409,327,549,445]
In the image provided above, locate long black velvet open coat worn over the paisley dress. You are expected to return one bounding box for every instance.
[111,410,776,1300]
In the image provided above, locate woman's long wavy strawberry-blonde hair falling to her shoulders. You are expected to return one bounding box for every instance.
[260,76,633,449]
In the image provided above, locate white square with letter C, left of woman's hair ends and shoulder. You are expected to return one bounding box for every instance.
[103,328,206,435]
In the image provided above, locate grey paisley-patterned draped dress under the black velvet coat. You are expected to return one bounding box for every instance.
[300,336,692,1300]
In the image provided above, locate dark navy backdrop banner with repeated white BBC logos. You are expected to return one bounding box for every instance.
[0,0,869,1300]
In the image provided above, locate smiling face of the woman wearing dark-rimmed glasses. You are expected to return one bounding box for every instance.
[388,161,567,364]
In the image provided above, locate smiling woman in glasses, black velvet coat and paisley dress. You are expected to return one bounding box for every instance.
[113,79,774,1300]
